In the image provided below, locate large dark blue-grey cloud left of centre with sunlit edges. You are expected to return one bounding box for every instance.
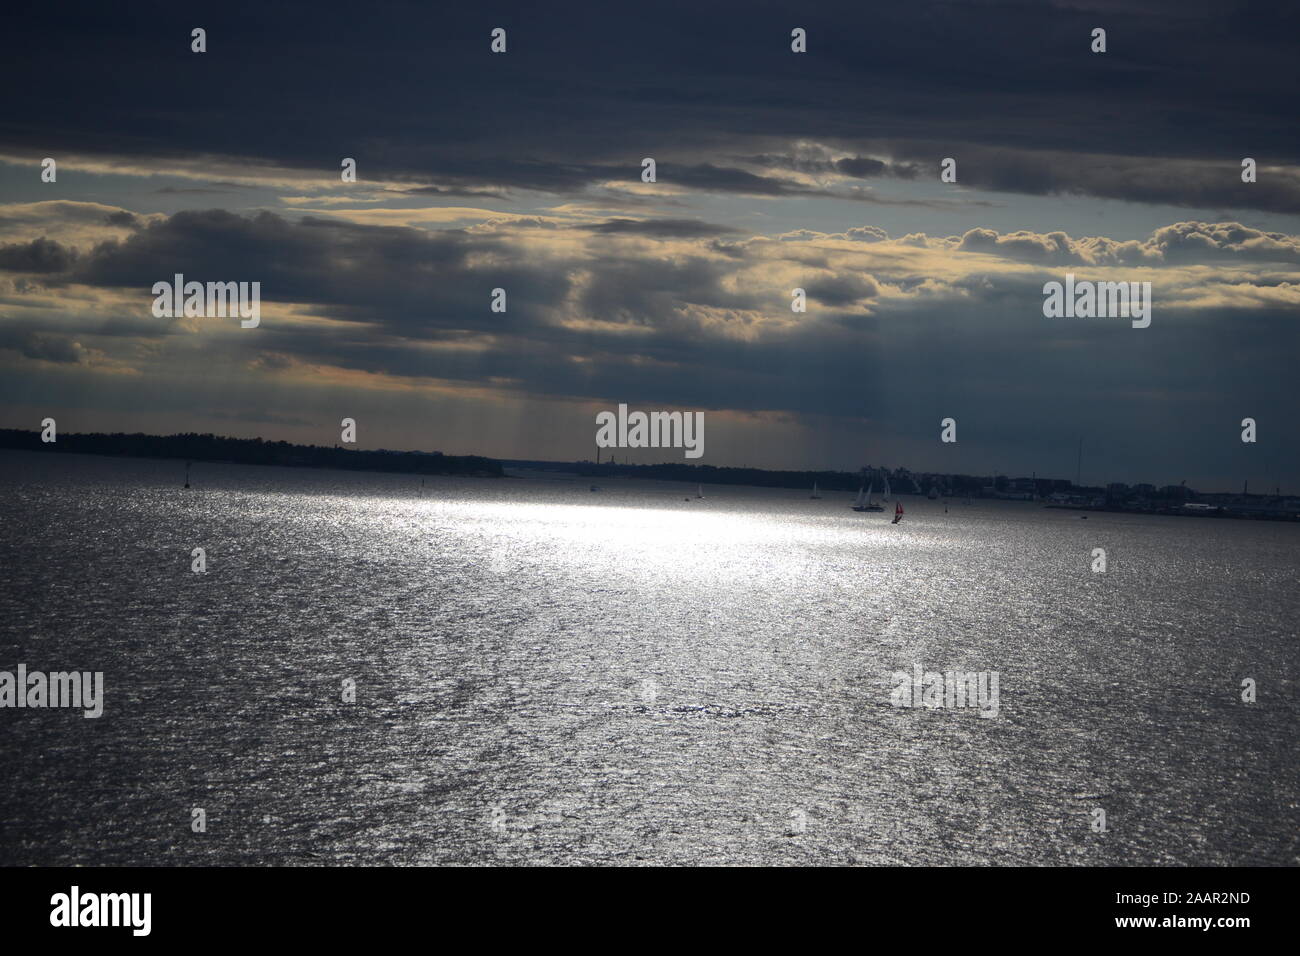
[53,209,569,338]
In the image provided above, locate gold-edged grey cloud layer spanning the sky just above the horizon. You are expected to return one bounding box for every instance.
[0,206,1300,486]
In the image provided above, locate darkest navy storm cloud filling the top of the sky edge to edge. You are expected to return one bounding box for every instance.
[0,0,1300,211]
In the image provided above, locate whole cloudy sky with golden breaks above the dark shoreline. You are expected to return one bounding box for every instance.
[0,0,1300,493]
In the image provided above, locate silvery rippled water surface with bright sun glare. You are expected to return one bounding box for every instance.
[0,451,1300,864]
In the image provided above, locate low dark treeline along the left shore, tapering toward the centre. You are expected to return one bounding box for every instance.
[0,428,502,477]
